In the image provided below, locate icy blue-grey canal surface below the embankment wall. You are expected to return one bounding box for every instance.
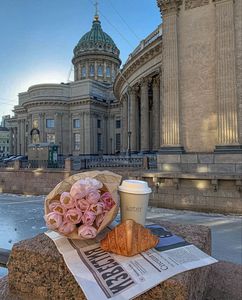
[0,194,242,277]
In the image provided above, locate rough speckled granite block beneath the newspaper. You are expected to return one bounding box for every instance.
[3,221,211,300]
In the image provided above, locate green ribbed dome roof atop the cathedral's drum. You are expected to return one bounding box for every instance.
[74,16,119,57]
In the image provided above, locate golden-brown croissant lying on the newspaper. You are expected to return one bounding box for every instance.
[101,220,159,256]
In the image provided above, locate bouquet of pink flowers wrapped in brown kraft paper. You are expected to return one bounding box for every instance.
[45,171,121,239]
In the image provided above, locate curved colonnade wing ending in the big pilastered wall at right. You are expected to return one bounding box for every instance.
[114,0,242,155]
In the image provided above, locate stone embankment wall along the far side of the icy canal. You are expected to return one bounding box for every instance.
[0,169,242,214]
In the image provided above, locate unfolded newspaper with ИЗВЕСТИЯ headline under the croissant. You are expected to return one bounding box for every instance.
[46,224,217,300]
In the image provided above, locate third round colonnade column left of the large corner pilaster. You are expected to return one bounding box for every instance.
[128,88,138,152]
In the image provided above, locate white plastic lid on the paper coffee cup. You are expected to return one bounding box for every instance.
[118,180,152,194]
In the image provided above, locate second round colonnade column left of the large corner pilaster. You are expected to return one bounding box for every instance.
[140,78,150,152]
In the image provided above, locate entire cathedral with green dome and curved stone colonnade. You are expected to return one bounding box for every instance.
[6,0,242,163]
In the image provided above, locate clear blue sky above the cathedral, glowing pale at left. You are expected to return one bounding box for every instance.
[0,0,161,121]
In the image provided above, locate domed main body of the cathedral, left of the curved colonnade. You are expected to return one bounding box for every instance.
[8,11,121,155]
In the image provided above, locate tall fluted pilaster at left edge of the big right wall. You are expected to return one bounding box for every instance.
[157,0,183,152]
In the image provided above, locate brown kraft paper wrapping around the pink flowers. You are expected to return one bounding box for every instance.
[45,171,122,240]
